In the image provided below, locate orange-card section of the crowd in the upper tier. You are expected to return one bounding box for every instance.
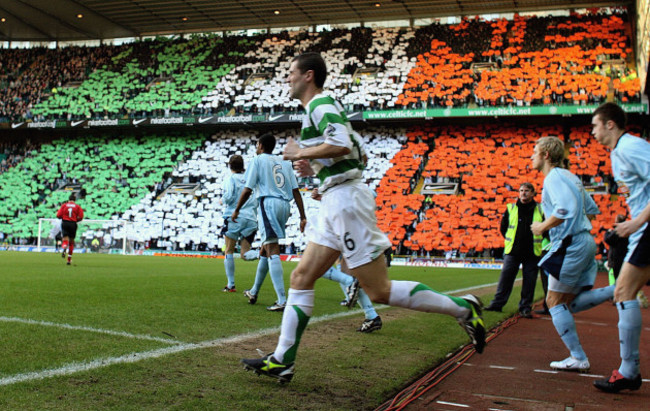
[396,14,641,108]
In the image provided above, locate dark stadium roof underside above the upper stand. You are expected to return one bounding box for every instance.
[0,0,634,41]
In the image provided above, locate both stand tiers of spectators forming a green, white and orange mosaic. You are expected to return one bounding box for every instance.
[0,10,641,257]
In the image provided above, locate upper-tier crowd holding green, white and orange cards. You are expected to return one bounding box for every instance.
[0,8,640,121]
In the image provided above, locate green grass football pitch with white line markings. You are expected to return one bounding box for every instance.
[0,252,520,410]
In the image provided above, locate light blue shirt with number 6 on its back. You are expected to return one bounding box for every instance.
[246,153,298,201]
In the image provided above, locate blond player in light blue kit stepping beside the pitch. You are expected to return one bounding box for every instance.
[530,137,614,372]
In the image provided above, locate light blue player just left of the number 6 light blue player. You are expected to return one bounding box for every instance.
[222,155,257,293]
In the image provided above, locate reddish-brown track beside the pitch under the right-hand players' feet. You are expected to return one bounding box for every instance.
[392,275,650,411]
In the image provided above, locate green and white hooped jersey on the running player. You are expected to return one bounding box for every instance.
[300,93,364,193]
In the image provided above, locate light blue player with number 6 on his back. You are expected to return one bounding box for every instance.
[231,133,307,311]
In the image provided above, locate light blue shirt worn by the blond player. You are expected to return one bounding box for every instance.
[542,167,600,246]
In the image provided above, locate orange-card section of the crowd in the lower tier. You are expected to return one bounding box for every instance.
[377,123,634,258]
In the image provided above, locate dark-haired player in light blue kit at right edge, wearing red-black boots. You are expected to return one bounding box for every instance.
[591,103,650,392]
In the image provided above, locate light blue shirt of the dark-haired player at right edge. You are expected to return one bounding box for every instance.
[610,133,650,218]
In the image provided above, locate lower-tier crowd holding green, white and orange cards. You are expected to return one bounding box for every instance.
[0,122,638,258]
